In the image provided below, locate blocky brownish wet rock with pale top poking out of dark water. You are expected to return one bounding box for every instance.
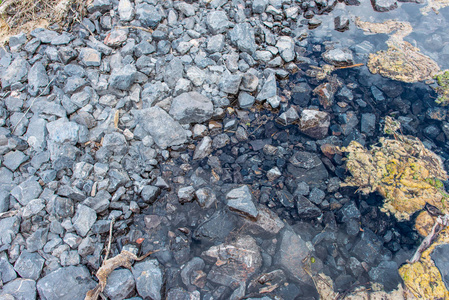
[299,109,330,140]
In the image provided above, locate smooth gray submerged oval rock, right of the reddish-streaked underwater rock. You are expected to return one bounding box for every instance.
[276,229,310,283]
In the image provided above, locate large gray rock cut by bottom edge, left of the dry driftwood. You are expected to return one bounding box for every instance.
[37,266,96,300]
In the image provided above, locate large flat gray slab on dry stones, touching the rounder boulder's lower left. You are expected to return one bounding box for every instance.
[140,107,187,149]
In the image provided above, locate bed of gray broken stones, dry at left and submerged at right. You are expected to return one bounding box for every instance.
[0,0,449,300]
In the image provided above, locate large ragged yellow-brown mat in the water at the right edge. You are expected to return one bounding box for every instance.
[341,118,447,220]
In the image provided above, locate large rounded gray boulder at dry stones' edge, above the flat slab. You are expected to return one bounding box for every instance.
[170,92,214,124]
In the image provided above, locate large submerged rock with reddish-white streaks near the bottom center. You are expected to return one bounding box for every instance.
[202,236,262,287]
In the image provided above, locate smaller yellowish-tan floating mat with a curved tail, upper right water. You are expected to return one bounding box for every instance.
[355,18,440,82]
